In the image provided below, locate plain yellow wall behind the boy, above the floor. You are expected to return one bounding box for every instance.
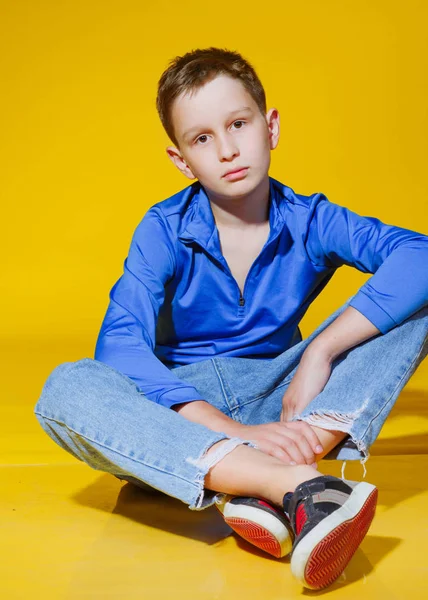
[0,0,428,350]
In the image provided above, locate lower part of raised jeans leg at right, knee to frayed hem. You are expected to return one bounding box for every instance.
[293,306,428,464]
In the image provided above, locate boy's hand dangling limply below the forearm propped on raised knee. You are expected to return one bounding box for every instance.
[280,346,332,421]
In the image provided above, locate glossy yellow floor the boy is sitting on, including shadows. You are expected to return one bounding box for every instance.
[0,342,428,600]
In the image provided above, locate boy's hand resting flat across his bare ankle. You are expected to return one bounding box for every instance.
[237,421,323,466]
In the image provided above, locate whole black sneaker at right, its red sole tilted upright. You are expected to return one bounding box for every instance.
[284,475,378,590]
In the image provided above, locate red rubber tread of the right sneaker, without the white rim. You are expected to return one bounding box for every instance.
[304,488,378,590]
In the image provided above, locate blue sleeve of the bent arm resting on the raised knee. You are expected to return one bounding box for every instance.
[305,194,428,333]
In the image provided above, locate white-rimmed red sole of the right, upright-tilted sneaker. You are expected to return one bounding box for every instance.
[291,482,378,590]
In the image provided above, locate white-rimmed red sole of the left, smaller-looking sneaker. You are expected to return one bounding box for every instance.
[216,503,293,558]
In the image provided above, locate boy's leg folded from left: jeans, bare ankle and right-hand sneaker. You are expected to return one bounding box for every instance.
[35,358,376,588]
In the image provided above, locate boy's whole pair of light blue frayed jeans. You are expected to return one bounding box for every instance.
[35,298,428,510]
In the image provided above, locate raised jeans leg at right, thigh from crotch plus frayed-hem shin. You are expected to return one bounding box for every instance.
[198,298,428,463]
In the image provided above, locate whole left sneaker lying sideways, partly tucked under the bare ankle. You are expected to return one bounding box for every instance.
[216,494,294,558]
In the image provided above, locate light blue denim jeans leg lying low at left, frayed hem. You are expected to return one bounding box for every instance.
[35,358,260,510]
